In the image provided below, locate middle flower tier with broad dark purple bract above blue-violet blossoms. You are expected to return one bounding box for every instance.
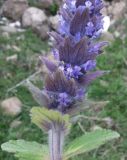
[44,38,107,81]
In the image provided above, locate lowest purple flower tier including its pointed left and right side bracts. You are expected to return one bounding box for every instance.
[27,70,104,114]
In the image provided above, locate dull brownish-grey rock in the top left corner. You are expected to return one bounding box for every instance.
[1,0,28,20]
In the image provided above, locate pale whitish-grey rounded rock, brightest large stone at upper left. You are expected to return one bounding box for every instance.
[22,7,47,28]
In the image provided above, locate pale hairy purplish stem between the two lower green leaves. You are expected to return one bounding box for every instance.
[49,126,64,160]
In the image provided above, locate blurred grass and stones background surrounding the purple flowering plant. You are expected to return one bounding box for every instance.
[0,0,127,160]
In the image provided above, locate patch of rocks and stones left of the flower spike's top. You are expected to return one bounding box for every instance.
[0,0,58,40]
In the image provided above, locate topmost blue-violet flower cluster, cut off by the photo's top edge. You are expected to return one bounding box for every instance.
[58,0,103,41]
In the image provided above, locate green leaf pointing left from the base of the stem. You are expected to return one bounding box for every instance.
[1,140,49,160]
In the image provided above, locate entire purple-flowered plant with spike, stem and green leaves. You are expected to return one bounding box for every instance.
[2,0,119,160]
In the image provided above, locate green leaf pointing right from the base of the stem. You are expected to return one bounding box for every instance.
[64,129,120,160]
